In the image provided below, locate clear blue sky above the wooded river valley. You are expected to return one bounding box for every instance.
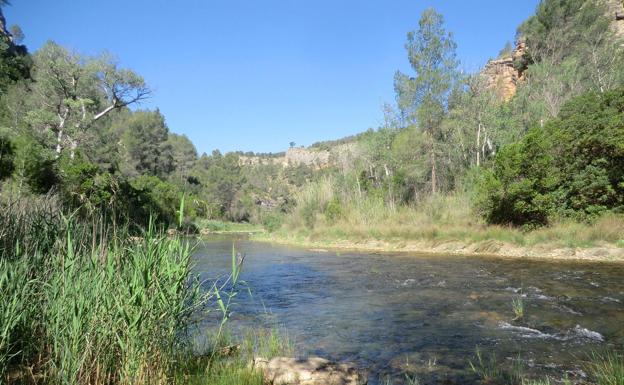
[4,0,538,153]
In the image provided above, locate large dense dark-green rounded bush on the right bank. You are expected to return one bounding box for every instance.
[476,88,624,227]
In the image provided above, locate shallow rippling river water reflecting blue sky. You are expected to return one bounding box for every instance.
[196,237,624,384]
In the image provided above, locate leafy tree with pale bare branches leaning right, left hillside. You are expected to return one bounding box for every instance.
[28,42,150,158]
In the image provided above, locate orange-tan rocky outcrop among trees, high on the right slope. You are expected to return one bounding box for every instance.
[481,41,526,101]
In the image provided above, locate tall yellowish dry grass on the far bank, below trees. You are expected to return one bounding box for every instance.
[275,177,624,252]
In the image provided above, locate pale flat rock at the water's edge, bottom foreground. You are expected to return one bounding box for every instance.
[253,357,367,385]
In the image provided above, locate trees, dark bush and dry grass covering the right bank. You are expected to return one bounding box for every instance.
[256,0,624,258]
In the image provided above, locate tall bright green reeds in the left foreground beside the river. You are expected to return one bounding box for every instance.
[0,198,272,385]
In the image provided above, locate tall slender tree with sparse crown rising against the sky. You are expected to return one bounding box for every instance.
[395,9,458,194]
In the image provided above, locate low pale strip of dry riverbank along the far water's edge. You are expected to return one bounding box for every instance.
[253,219,624,262]
